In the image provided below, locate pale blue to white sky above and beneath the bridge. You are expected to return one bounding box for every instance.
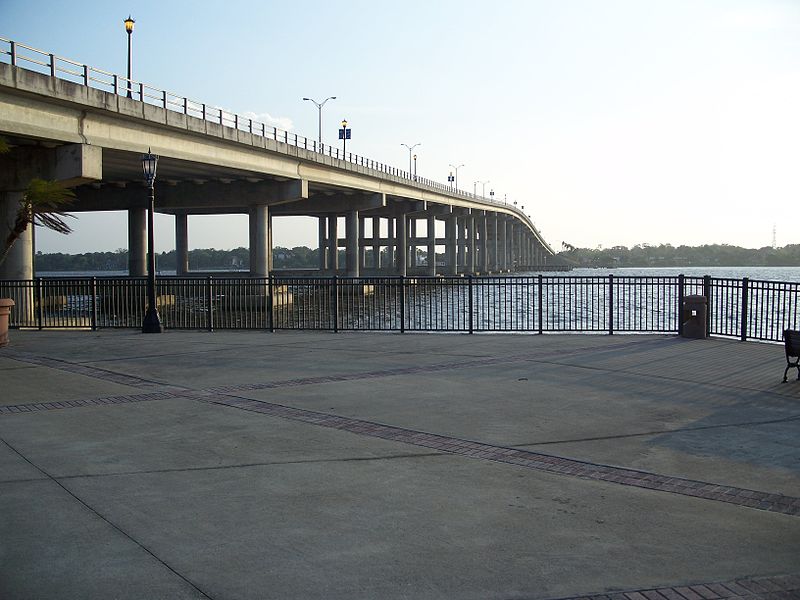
[0,0,800,252]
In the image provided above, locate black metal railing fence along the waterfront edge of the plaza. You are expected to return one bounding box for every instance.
[0,275,800,342]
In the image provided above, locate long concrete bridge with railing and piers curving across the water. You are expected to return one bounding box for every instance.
[0,38,553,279]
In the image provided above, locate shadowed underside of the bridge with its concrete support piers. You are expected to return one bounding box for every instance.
[0,137,549,279]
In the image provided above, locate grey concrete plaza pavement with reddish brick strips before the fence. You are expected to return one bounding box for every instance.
[0,331,800,600]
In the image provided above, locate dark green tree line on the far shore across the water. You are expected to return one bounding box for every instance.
[35,244,800,271]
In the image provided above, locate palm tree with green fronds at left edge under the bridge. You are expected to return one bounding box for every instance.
[0,137,75,264]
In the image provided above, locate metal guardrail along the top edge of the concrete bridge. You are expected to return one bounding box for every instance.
[0,37,555,254]
